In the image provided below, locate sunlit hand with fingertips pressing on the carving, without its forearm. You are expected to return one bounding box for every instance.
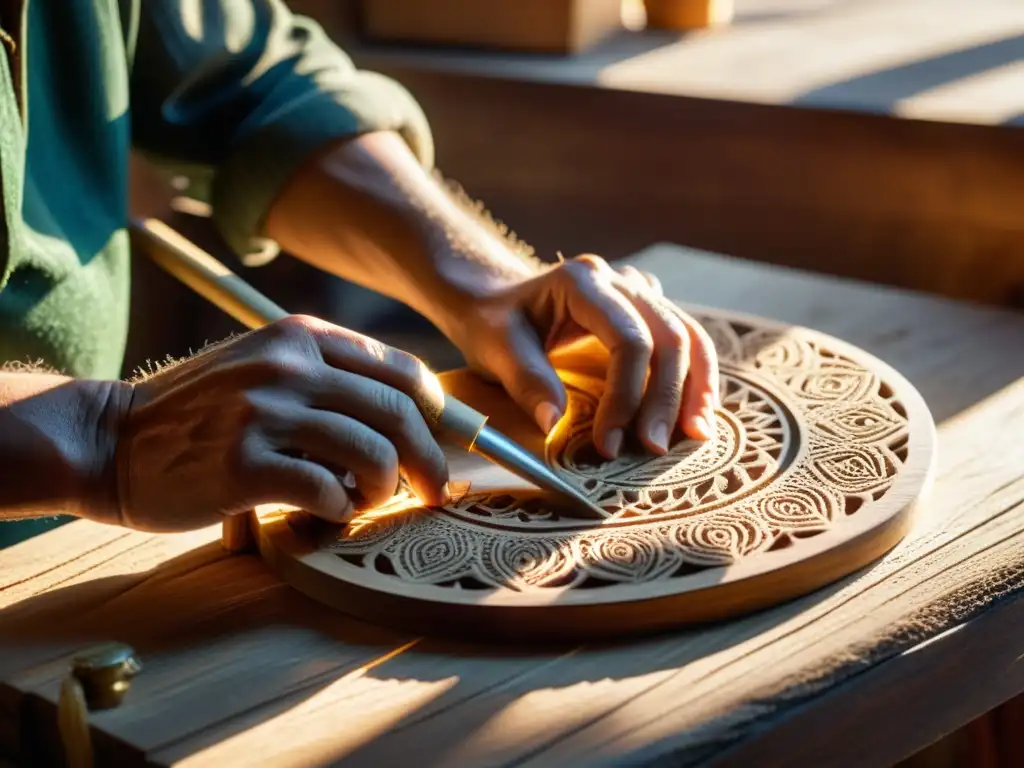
[453,254,719,459]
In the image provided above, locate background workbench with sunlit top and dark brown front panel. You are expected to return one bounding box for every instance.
[317,0,1024,304]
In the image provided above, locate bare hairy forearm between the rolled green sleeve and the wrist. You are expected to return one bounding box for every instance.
[265,132,544,339]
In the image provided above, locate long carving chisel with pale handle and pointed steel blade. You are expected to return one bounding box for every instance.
[131,219,607,525]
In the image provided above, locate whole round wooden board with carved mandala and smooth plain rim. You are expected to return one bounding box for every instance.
[257,310,935,640]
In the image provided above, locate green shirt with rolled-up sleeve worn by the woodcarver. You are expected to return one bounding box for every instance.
[0,0,433,547]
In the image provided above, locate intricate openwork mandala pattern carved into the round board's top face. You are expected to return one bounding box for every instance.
[321,317,908,591]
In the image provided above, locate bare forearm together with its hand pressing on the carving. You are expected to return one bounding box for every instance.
[260,132,718,457]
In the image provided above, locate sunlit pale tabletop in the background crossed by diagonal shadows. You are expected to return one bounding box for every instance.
[346,0,1024,126]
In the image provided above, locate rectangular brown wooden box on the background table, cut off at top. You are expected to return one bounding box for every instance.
[364,0,622,53]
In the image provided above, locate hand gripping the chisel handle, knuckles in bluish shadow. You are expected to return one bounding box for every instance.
[103,315,449,531]
